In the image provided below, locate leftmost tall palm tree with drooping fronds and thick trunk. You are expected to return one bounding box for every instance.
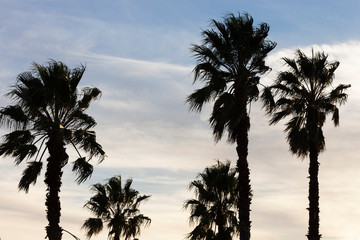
[0,60,105,240]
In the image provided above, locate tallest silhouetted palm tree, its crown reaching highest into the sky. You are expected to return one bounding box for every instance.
[187,11,276,240]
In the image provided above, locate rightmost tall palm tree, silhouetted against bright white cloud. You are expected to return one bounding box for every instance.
[262,50,350,240]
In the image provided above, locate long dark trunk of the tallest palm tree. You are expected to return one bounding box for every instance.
[236,83,251,240]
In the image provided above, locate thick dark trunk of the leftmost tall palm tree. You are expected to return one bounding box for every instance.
[45,133,67,240]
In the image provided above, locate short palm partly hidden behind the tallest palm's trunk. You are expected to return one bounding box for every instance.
[184,161,239,240]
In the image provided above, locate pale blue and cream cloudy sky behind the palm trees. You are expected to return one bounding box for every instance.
[0,0,360,240]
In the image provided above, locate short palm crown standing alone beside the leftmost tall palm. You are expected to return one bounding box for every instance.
[83,176,151,240]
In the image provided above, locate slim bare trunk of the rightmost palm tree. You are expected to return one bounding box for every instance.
[307,146,321,240]
